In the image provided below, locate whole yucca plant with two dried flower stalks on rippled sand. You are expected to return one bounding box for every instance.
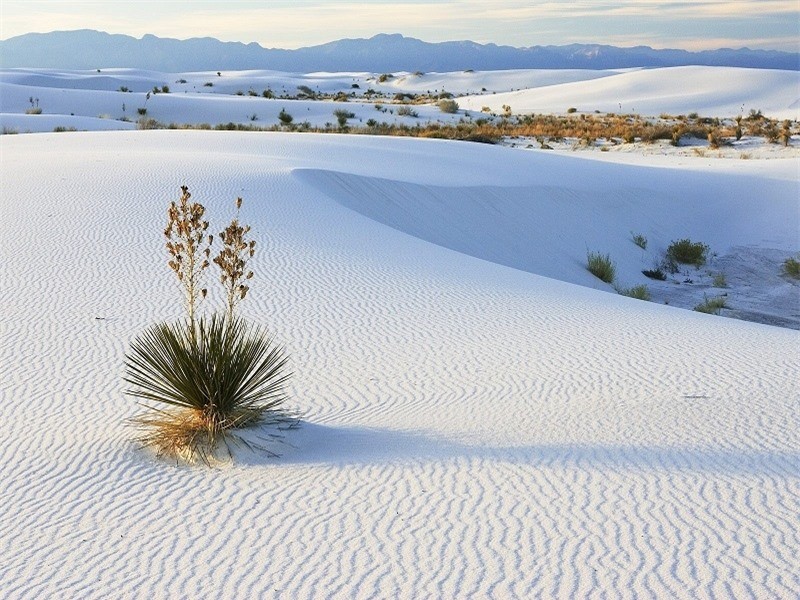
[125,186,289,463]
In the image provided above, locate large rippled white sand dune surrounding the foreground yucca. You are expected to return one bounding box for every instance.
[0,129,800,599]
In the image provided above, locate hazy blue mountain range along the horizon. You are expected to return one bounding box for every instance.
[0,29,800,72]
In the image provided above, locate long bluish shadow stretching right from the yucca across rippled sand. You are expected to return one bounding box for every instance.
[236,421,800,476]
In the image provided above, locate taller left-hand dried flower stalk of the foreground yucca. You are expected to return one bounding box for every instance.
[164,185,213,332]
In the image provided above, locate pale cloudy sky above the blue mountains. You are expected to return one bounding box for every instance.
[0,0,800,51]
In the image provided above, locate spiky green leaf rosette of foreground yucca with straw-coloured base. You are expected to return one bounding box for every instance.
[125,315,290,461]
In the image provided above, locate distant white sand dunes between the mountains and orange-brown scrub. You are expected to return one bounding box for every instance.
[0,67,800,133]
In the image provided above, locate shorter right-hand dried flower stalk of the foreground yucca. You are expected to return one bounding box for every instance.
[214,198,256,322]
